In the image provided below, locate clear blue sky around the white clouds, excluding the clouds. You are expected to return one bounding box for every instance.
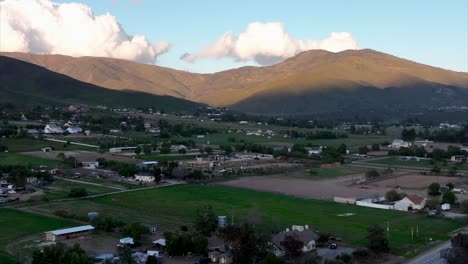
[44,0,468,72]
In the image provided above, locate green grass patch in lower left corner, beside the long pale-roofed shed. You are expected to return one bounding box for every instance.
[0,208,76,264]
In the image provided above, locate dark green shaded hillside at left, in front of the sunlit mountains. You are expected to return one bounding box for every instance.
[0,56,202,112]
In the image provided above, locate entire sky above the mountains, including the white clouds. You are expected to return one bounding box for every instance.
[0,0,468,73]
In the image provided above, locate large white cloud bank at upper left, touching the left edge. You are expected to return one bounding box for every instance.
[0,0,170,63]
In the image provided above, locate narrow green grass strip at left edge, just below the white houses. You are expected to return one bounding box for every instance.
[0,138,94,152]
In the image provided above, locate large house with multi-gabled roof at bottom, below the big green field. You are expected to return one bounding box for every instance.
[271,225,319,256]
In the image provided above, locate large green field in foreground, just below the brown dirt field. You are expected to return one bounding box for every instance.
[28,185,463,256]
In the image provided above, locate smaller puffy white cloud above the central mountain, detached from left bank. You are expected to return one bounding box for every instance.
[181,22,359,65]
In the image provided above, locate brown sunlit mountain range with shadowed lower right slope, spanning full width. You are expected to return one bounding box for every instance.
[0,49,468,115]
